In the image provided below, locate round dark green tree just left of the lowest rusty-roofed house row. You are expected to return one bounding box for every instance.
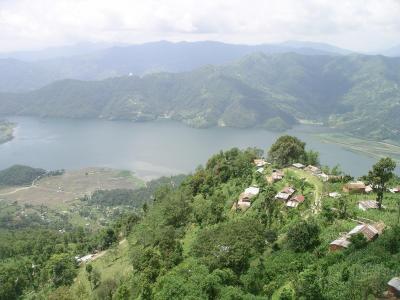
[287,221,320,252]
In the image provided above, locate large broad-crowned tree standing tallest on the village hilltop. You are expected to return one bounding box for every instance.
[268,135,306,167]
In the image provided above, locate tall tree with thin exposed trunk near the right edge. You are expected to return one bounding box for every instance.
[367,157,396,209]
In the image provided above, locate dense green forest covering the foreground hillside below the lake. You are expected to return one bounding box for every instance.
[0,136,400,299]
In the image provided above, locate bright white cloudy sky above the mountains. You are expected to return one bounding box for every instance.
[0,0,400,52]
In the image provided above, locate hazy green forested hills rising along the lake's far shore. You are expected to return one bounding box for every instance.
[0,53,400,140]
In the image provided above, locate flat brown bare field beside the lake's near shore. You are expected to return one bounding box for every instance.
[0,168,144,206]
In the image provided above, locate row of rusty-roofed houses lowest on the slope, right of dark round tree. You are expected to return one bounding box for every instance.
[329,223,384,251]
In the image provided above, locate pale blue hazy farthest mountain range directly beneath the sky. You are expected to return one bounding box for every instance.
[0,41,350,92]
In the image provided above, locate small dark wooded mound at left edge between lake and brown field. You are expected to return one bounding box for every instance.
[0,165,46,186]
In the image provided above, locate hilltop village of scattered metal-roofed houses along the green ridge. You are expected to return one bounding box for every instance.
[232,158,400,299]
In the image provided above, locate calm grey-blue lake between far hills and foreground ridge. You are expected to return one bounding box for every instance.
[0,117,382,179]
